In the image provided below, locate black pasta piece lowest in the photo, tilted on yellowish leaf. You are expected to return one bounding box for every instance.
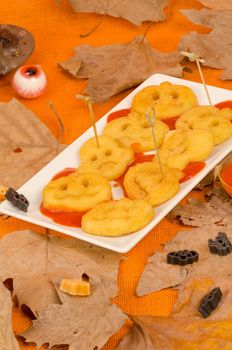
[198,287,222,318]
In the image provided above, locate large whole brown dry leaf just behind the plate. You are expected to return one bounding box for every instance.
[59,36,182,102]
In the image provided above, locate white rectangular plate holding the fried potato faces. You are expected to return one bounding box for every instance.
[0,74,232,253]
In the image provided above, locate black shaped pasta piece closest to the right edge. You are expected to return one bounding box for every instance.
[208,232,232,256]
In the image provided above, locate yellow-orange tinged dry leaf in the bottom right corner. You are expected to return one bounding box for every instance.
[134,274,232,350]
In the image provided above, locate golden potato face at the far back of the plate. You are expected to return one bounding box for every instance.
[131,82,197,119]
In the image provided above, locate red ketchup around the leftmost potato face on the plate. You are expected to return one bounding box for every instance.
[40,168,85,227]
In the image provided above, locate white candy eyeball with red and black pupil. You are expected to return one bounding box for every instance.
[12,64,47,99]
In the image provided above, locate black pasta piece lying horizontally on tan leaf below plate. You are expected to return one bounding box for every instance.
[167,250,199,266]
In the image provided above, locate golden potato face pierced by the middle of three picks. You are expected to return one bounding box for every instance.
[123,162,184,207]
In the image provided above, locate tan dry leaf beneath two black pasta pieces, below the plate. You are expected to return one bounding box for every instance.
[137,225,232,296]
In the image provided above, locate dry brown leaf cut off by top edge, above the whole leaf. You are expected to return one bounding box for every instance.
[69,0,168,25]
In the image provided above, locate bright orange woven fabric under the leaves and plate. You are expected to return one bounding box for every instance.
[0,0,232,350]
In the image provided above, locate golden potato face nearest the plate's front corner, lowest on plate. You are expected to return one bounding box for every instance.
[81,198,154,237]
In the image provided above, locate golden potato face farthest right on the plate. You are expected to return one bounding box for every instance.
[176,106,232,145]
